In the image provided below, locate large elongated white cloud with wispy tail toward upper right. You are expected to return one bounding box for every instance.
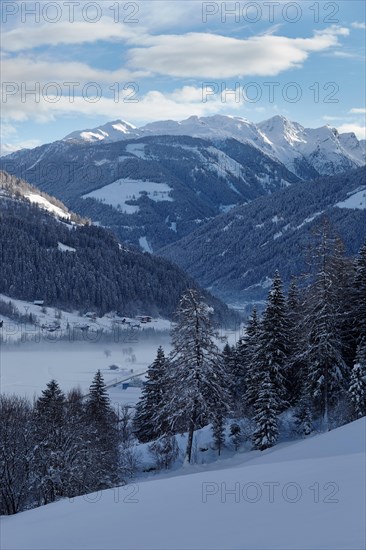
[127,26,349,78]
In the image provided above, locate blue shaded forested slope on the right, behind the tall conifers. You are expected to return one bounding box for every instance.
[160,168,366,302]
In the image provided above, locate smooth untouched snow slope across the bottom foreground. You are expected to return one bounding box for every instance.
[0,419,366,550]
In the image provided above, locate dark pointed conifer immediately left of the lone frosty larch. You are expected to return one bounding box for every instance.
[133,346,169,443]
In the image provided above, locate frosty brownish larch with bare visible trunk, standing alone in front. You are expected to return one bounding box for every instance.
[164,289,229,462]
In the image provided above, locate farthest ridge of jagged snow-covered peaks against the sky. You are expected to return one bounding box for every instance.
[64,115,366,179]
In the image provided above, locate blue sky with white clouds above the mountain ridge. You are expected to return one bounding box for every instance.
[1,0,366,153]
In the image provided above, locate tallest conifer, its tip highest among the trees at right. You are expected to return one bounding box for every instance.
[298,220,348,431]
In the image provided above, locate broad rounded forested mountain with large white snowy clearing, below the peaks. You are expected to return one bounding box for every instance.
[0,135,300,251]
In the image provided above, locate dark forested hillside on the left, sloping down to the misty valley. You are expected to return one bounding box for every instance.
[0,170,231,319]
